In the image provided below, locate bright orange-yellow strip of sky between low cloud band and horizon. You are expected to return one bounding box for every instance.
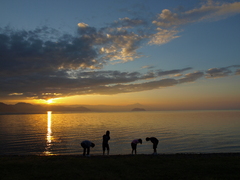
[0,75,240,110]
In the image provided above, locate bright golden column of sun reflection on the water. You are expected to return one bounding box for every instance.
[44,111,53,155]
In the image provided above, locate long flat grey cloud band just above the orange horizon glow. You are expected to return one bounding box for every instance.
[0,66,236,99]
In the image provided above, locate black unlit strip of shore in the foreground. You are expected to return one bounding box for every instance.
[0,154,240,180]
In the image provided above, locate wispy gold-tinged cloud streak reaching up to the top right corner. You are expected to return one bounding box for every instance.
[149,0,240,45]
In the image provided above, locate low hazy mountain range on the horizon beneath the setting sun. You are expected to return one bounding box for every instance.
[0,102,91,114]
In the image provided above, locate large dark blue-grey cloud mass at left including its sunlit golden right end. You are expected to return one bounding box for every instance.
[0,23,146,76]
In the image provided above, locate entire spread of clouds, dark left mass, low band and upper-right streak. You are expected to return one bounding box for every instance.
[0,1,240,99]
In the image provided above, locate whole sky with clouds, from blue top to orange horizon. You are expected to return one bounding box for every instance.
[0,0,240,109]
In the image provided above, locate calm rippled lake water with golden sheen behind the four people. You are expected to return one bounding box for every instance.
[0,111,240,155]
